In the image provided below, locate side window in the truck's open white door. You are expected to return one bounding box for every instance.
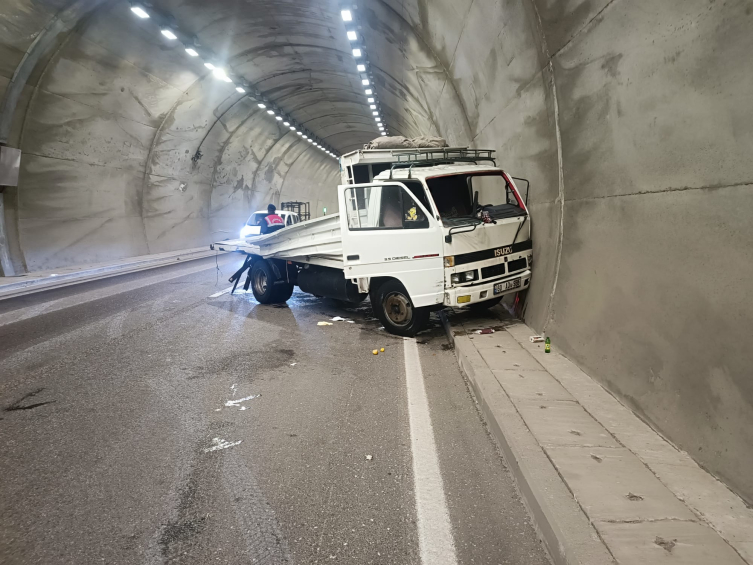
[345,185,429,230]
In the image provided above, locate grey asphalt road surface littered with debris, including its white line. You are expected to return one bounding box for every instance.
[0,256,549,565]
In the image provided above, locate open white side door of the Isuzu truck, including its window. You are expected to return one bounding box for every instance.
[338,182,444,307]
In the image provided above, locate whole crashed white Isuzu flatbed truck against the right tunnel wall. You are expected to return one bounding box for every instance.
[212,148,532,336]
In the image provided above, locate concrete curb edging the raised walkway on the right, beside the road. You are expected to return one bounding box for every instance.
[440,316,615,565]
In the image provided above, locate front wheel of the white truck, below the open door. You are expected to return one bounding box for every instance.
[371,280,430,337]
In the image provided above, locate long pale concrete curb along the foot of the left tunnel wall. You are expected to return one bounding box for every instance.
[0,247,225,300]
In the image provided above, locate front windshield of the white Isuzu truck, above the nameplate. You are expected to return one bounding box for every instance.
[426,173,524,223]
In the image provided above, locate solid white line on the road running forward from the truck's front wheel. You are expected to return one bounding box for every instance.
[403,338,457,565]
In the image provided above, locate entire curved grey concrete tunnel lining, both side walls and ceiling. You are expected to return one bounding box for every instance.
[0,0,753,502]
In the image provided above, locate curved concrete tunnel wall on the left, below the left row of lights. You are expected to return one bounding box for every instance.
[3,2,339,272]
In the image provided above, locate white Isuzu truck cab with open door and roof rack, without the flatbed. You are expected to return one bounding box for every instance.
[338,148,532,328]
